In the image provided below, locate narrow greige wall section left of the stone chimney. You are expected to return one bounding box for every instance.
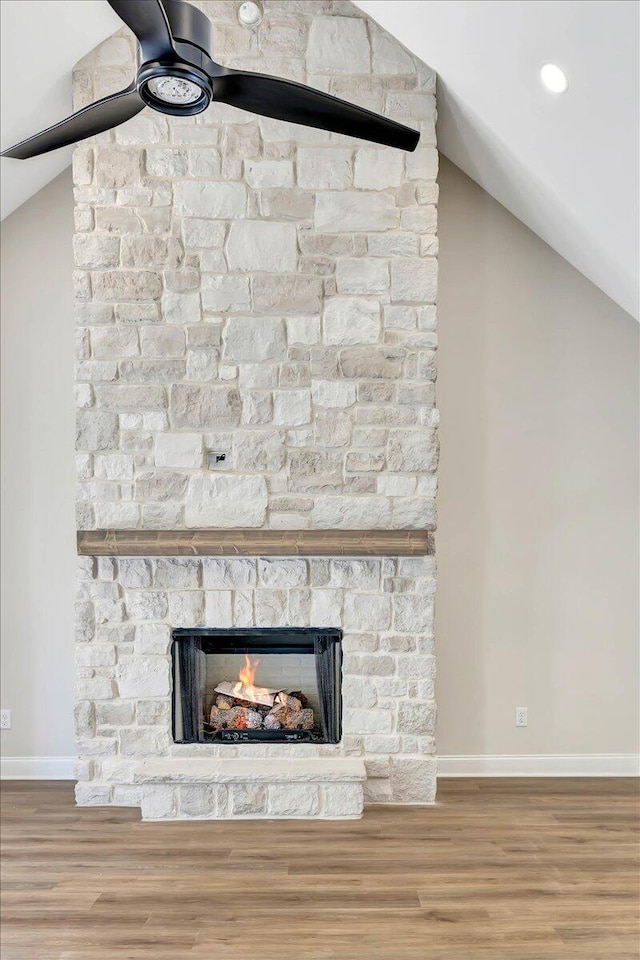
[1,169,75,757]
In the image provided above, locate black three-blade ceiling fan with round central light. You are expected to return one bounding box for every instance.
[0,0,420,160]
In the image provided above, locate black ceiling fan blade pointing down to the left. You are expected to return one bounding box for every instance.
[0,83,144,160]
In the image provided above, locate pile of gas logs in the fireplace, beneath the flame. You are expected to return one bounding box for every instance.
[208,682,314,730]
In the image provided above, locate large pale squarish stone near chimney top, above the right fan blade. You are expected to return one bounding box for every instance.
[307,16,371,75]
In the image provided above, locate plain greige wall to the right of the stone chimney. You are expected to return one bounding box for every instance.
[436,160,640,755]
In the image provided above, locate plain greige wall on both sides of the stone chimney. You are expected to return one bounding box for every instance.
[2,160,640,768]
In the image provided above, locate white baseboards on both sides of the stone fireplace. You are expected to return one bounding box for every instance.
[0,753,640,780]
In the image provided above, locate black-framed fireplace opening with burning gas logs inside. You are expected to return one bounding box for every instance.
[172,627,342,744]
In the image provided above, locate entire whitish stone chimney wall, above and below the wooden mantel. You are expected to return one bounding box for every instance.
[74,0,437,803]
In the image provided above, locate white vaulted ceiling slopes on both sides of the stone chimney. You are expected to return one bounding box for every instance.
[0,0,639,316]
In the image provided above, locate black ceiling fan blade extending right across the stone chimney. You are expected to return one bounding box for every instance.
[211,70,420,151]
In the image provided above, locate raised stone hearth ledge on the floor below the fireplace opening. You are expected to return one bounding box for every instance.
[135,757,366,820]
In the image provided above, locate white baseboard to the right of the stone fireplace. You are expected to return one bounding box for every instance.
[438,753,640,777]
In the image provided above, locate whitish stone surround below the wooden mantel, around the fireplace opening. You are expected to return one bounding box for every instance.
[76,557,435,804]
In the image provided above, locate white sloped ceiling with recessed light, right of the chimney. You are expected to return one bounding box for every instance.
[358,0,640,317]
